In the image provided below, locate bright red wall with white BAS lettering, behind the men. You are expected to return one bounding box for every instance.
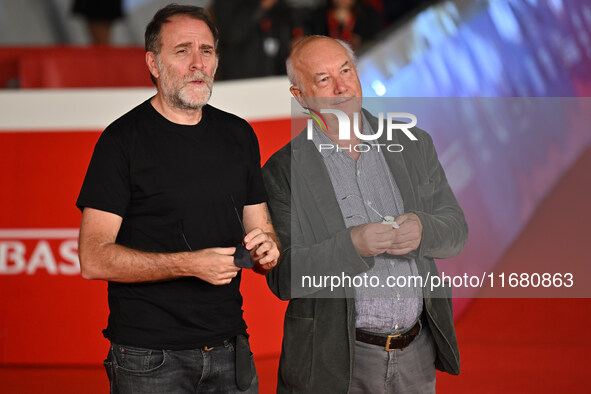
[0,119,290,364]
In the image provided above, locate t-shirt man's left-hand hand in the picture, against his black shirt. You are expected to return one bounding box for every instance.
[193,247,240,285]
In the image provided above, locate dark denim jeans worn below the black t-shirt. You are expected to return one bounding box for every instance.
[104,341,259,394]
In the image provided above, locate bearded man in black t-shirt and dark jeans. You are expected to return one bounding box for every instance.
[77,5,279,393]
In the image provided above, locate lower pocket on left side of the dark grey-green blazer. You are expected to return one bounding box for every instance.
[279,315,314,391]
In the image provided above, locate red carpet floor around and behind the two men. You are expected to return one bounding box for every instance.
[0,150,591,394]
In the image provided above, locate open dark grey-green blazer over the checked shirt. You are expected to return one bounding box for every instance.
[263,112,468,393]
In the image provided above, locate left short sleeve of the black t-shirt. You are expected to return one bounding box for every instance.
[76,128,130,217]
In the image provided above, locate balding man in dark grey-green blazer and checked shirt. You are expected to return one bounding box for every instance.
[263,36,468,393]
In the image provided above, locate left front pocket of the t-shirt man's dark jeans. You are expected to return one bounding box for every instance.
[111,344,166,375]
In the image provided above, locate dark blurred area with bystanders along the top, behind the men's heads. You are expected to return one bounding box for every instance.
[0,0,434,79]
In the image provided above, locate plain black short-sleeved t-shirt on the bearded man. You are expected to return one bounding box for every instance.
[76,100,266,350]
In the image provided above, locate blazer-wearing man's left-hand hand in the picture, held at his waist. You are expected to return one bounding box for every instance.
[351,222,396,257]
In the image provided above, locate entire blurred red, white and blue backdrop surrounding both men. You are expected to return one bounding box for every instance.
[0,0,591,393]
